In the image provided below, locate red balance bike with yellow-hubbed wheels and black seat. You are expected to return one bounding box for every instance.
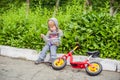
[52,45,102,76]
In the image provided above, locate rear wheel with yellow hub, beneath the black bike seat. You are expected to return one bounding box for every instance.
[86,62,102,76]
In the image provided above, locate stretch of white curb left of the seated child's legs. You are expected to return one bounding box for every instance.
[0,46,38,61]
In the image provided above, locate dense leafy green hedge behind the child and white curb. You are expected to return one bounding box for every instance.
[0,0,120,59]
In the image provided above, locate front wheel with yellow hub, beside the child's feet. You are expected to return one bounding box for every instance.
[52,59,67,70]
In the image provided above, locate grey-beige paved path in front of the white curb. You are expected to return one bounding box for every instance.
[0,56,120,80]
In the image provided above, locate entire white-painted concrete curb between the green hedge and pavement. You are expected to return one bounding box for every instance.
[0,45,120,72]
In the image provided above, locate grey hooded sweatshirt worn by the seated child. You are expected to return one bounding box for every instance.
[43,18,63,46]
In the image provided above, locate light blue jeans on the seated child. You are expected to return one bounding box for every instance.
[39,44,57,59]
